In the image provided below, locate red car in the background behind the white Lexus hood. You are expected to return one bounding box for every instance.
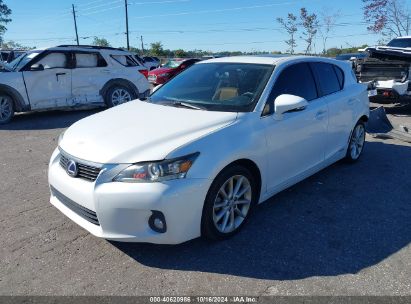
[148,59,200,85]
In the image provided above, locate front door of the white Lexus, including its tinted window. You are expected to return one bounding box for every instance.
[262,63,328,192]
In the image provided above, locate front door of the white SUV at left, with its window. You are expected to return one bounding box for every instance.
[23,51,71,110]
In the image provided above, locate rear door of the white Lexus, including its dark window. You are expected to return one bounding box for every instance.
[310,62,356,159]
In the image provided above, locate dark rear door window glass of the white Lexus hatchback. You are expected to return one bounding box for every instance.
[310,62,341,96]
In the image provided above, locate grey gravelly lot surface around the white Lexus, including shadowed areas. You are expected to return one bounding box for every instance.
[0,102,411,295]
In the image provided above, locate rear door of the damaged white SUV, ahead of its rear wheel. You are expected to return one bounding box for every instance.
[72,51,109,105]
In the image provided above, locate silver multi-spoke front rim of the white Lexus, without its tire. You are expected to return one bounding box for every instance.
[213,175,252,234]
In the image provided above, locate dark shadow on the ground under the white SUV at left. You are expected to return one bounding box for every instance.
[0,108,104,130]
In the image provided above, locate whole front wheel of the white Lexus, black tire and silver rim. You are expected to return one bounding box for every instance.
[201,165,258,240]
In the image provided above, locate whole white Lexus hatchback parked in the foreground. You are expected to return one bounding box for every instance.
[49,56,369,244]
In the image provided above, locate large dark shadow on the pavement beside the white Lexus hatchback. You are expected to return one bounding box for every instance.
[110,142,411,280]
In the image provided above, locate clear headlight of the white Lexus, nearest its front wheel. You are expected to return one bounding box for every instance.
[113,152,200,183]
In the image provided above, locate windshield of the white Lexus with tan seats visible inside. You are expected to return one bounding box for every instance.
[150,63,274,112]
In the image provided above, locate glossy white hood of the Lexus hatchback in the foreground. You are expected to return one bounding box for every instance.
[60,100,237,164]
